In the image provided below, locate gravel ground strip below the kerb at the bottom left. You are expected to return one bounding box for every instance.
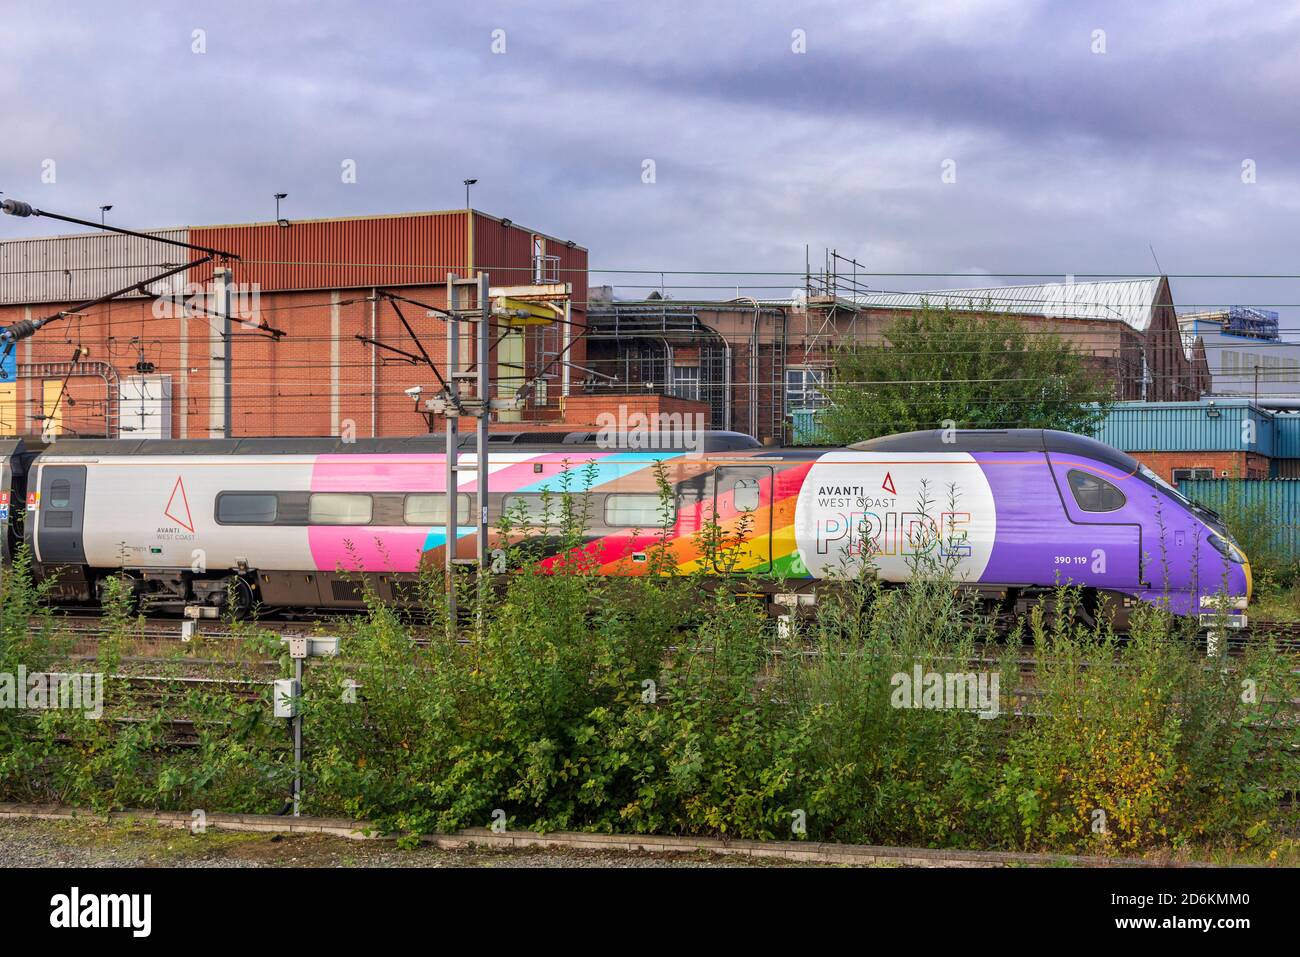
[0,819,810,869]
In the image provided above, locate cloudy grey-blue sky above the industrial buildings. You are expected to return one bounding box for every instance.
[0,0,1300,321]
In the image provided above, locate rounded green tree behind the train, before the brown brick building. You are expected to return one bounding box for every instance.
[819,306,1114,445]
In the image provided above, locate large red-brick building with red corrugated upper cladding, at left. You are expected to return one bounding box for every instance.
[0,209,624,438]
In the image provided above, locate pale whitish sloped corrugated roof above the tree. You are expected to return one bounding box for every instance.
[850,277,1160,333]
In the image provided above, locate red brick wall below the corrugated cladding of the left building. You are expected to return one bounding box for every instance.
[0,285,582,438]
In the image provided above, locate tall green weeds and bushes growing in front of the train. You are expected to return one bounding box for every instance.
[0,480,1300,853]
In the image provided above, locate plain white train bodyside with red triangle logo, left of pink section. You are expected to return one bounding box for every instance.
[35,455,316,571]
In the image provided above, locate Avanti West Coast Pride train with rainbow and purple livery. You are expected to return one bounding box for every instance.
[0,429,1251,619]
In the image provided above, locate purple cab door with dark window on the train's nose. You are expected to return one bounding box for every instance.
[1049,456,1145,588]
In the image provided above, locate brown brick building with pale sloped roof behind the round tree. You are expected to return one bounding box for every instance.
[588,277,1210,442]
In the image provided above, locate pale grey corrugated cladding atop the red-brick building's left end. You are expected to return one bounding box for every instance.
[0,229,198,304]
